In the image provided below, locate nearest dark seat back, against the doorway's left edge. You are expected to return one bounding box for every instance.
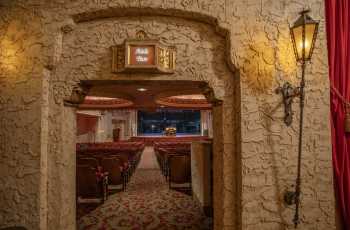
[76,165,103,198]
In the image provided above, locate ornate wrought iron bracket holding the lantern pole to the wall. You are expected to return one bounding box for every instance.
[275,82,300,126]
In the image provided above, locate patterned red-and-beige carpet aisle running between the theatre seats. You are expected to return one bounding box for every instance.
[78,148,211,230]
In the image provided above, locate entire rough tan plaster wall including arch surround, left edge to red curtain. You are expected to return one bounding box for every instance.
[0,0,335,230]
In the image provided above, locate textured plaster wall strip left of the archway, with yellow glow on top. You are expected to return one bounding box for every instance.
[0,3,45,229]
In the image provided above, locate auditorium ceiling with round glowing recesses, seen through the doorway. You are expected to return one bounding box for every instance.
[79,81,211,110]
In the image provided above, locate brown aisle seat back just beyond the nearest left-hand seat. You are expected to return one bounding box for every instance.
[101,157,123,185]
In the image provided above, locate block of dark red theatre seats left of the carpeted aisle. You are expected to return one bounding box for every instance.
[76,142,144,203]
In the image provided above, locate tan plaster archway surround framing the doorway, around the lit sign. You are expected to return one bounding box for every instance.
[47,9,241,229]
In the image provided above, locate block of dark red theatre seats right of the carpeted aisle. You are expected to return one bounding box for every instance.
[154,141,192,192]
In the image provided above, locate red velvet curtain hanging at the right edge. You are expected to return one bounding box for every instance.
[325,0,350,227]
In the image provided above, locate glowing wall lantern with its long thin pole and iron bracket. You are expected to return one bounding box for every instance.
[276,10,319,228]
